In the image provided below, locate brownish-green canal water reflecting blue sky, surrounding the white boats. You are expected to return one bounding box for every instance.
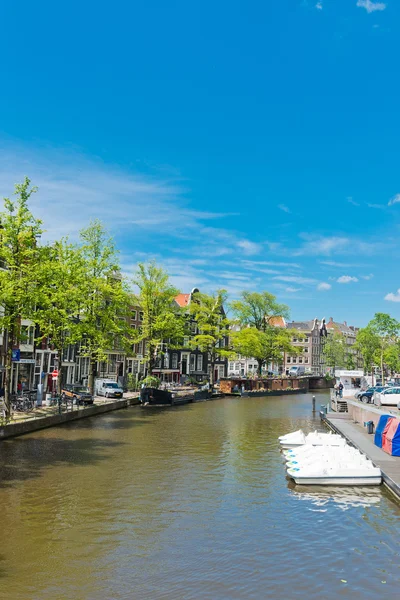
[0,394,400,600]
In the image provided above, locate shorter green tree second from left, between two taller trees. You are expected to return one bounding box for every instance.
[35,239,86,394]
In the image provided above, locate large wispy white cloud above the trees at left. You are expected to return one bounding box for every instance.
[0,147,230,239]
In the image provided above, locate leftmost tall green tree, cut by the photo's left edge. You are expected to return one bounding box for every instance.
[0,177,43,417]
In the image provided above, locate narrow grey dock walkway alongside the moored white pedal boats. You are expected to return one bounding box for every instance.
[321,413,400,498]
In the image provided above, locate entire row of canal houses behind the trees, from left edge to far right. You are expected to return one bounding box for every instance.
[0,288,357,395]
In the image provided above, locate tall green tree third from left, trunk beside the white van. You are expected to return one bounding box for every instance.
[77,220,131,394]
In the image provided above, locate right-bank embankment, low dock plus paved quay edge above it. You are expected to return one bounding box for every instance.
[321,400,400,499]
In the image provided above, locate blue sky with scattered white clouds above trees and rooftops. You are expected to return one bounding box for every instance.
[0,0,400,325]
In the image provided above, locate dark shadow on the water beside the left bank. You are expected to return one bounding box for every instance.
[0,436,124,488]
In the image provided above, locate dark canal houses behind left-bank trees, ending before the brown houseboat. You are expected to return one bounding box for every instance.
[0,288,229,395]
